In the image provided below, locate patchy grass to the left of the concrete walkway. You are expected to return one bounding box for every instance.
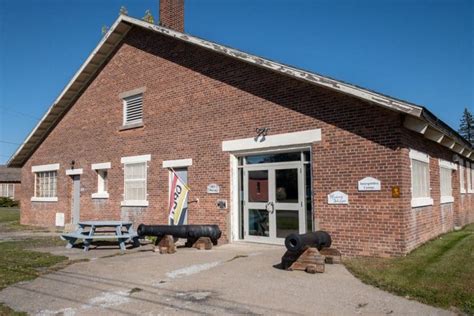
[0,208,69,315]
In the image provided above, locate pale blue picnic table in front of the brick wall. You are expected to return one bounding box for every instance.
[61,221,140,251]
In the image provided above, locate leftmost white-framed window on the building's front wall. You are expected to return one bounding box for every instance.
[31,164,59,202]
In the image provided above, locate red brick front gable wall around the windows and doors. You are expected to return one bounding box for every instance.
[21,25,474,256]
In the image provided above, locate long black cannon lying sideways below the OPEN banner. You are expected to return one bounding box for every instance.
[137,224,222,247]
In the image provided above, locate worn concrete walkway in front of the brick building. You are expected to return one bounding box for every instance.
[0,244,450,315]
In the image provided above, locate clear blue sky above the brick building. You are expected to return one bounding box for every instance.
[0,0,474,164]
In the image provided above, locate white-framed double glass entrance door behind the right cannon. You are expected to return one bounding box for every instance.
[243,162,306,244]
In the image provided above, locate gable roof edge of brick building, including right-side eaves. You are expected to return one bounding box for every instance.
[8,15,474,167]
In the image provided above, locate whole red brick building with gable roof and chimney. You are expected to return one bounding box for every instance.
[5,0,474,256]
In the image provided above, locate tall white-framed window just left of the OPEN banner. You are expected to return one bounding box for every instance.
[121,155,151,206]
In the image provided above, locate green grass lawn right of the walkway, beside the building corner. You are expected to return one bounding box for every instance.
[344,224,474,315]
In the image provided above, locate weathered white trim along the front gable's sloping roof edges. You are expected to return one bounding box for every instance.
[7,15,474,167]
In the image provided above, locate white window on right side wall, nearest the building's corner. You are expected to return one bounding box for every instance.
[410,149,433,207]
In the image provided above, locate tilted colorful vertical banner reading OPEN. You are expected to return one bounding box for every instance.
[169,169,189,225]
